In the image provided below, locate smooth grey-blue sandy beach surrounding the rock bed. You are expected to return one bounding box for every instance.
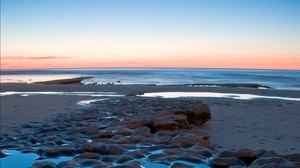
[1,83,300,167]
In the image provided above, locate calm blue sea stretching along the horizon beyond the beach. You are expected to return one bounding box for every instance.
[1,68,300,90]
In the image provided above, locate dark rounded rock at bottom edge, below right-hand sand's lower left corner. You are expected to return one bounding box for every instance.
[209,157,247,168]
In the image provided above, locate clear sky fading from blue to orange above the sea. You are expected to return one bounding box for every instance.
[1,0,300,70]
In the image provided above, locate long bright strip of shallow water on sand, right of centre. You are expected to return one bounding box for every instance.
[140,92,300,101]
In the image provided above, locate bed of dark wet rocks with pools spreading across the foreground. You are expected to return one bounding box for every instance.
[0,96,300,168]
